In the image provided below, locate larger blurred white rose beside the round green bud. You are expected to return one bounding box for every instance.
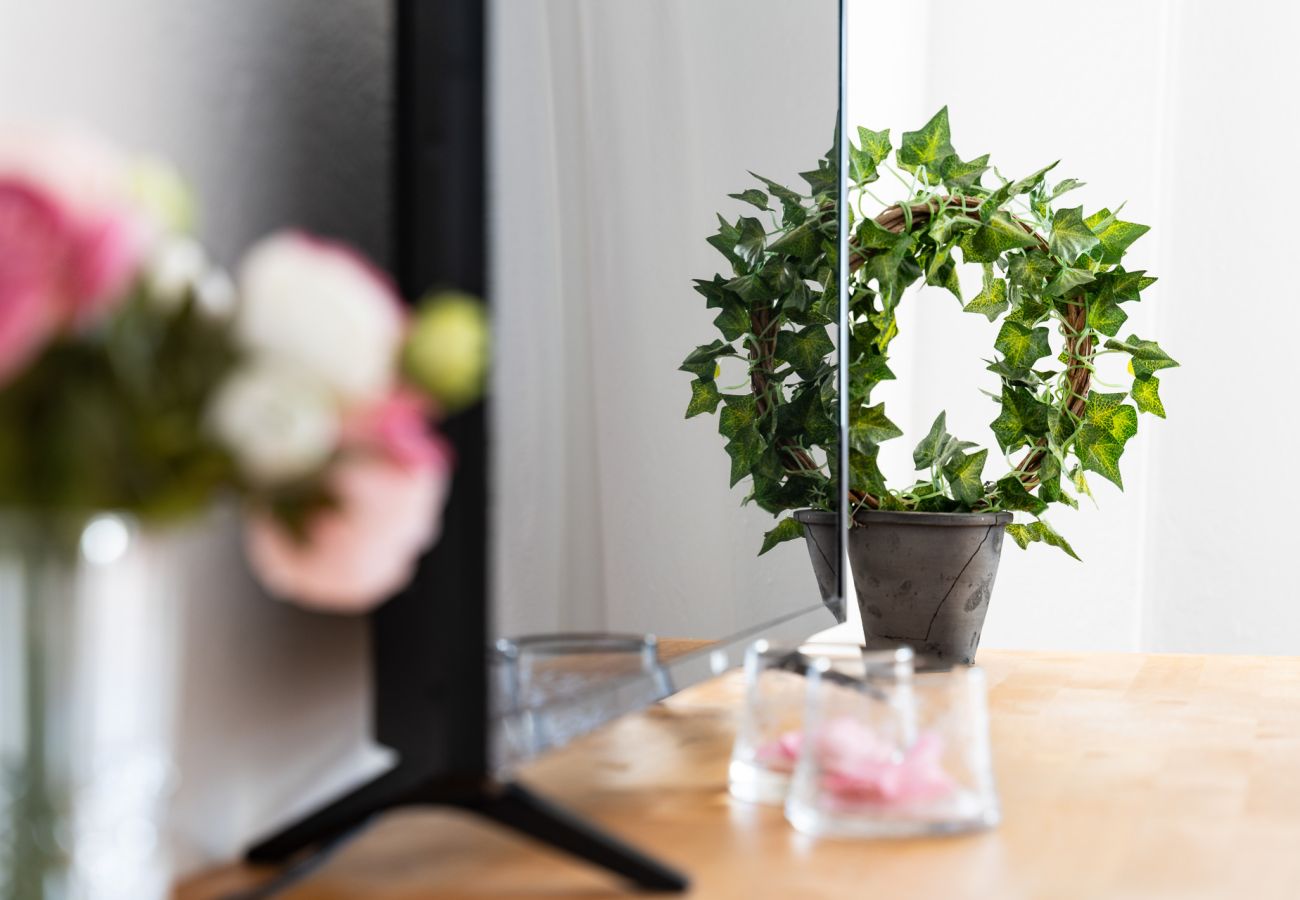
[235,233,404,402]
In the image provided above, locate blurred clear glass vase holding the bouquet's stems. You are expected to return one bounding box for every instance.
[0,514,179,900]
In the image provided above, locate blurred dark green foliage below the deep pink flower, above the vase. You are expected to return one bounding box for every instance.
[0,285,235,519]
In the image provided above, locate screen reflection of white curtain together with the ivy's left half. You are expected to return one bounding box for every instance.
[490,0,839,743]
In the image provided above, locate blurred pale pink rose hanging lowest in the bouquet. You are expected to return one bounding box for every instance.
[246,455,450,613]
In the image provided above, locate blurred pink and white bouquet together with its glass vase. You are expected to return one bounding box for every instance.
[0,129,486,900]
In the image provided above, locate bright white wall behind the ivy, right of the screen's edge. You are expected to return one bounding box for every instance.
[849,0,1300,653]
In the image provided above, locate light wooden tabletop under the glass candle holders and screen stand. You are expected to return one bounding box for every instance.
[178,650,1300,900]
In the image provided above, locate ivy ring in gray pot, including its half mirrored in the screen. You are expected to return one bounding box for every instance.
[681,107,1178,662]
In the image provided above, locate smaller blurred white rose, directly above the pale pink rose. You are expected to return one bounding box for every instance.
[209,360,339,485]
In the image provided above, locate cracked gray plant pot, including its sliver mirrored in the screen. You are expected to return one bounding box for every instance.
[796,511,1011,663]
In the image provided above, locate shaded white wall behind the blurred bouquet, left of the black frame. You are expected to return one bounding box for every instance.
[0,0,393,866]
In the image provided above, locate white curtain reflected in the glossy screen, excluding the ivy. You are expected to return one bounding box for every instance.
[490,0,837,637]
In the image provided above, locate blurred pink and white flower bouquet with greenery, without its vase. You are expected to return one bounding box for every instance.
[0,122,486,611]
